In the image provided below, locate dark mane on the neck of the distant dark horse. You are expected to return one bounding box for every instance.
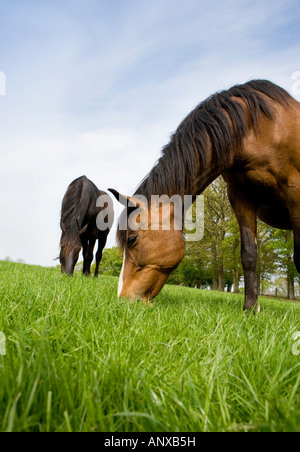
[61,176,87,244]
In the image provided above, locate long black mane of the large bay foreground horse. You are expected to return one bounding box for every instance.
[117,80,292,247]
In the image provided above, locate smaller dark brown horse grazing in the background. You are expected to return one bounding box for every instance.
[60,176,114,277]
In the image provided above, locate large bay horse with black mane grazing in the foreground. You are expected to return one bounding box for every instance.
[109,80,300,309]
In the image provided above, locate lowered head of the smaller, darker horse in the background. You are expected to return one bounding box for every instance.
[59,222,88,276]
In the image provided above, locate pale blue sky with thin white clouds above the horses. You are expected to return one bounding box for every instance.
[0,0,300,266]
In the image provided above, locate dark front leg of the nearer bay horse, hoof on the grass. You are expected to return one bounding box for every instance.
[228,187,260,312]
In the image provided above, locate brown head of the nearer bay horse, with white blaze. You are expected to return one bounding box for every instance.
[110,189,185,302]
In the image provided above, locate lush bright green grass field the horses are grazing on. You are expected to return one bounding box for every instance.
[0,262,300,432]
